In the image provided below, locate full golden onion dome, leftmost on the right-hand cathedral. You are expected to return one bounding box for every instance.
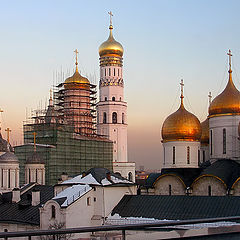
[162,96,201,142]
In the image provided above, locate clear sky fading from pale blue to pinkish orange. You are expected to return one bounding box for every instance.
[0,0,240,170]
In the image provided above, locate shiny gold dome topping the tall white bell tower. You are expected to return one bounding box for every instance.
[98,25,123,57]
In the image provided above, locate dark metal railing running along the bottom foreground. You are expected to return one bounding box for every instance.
[0,216,240,240]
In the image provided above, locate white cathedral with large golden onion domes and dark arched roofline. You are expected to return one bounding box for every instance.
[146,50,240,196]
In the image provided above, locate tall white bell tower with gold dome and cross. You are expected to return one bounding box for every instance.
[97,12,135,180]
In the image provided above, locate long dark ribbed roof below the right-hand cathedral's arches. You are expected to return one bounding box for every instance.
[111,195,240,220]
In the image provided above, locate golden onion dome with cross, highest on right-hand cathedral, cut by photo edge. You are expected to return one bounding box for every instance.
[208,50,240,117]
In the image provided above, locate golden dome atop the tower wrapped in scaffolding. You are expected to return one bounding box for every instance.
[64,63,90,89]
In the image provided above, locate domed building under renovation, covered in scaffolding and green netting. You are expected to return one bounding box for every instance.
[15,50,113,184]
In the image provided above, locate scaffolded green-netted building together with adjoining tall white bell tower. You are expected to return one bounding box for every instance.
[15,12,135,184]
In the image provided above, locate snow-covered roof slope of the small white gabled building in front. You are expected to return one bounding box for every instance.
[53,184,92,207]
